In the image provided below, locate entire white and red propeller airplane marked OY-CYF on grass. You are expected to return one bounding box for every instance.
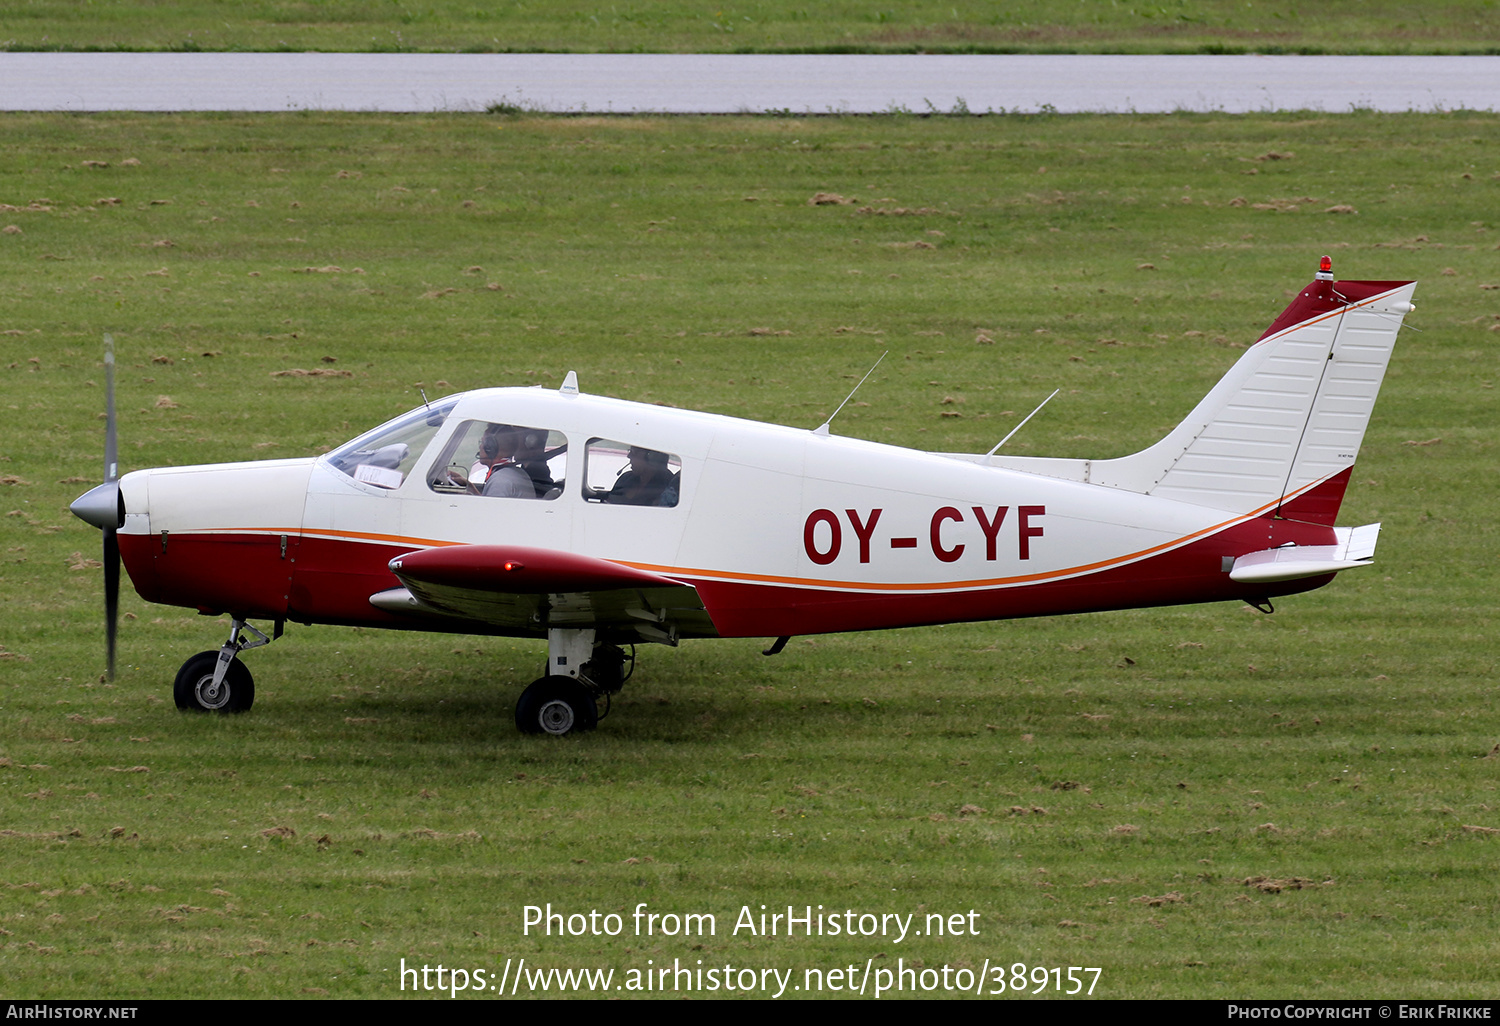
[72,257,1415,734]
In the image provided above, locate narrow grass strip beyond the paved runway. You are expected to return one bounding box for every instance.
[0,0,1500,54]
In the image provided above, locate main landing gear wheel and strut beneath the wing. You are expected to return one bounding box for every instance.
[516,629,636,737]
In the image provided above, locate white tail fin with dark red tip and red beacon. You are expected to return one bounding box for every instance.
[1089,258,1416,522]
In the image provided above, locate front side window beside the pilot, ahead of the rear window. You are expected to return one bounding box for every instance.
[428,420,567,500]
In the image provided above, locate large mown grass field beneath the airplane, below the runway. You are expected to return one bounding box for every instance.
[0,114,1500,998]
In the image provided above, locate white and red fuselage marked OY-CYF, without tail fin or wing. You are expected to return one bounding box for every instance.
[119,389,1347,636]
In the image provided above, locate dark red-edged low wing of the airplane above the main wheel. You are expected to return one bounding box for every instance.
[371,545,717,645]
